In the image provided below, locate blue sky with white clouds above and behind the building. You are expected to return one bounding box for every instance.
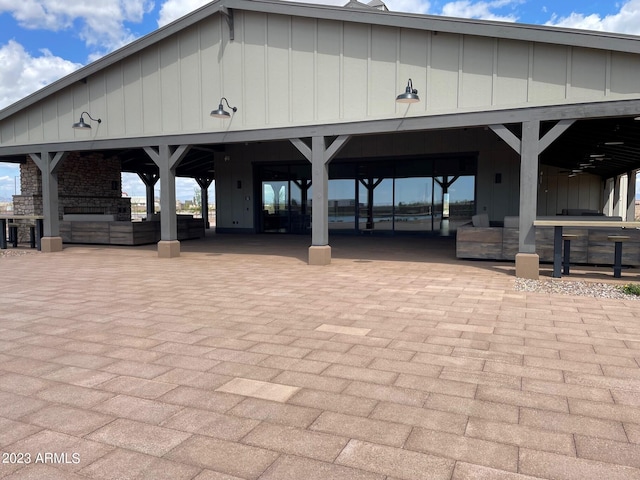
[0,0,640,200]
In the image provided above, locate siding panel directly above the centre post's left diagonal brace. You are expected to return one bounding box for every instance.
[290,18,317,124]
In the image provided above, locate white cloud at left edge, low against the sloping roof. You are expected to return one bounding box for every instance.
[0,40,82,108]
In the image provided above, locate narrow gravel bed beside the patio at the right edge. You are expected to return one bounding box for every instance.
[515,278,640,300]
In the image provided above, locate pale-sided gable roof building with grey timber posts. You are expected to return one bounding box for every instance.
[0,0,640,276]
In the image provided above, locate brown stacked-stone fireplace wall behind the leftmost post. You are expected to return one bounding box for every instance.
[13,152,131,229]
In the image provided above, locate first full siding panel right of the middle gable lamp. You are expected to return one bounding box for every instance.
[243,13,268,127]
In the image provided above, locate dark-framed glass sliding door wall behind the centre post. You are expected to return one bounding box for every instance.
[256,155,477,235]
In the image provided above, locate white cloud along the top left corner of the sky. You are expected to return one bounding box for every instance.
[0,0,154,53]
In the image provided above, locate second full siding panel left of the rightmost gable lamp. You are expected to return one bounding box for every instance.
[343,23,369,119]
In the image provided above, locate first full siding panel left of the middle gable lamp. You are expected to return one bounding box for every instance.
[179,27,204,132]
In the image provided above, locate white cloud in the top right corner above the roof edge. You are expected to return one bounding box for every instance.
[547,0,640,35]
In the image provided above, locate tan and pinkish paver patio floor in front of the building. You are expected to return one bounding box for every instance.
[0,235,640,480]
